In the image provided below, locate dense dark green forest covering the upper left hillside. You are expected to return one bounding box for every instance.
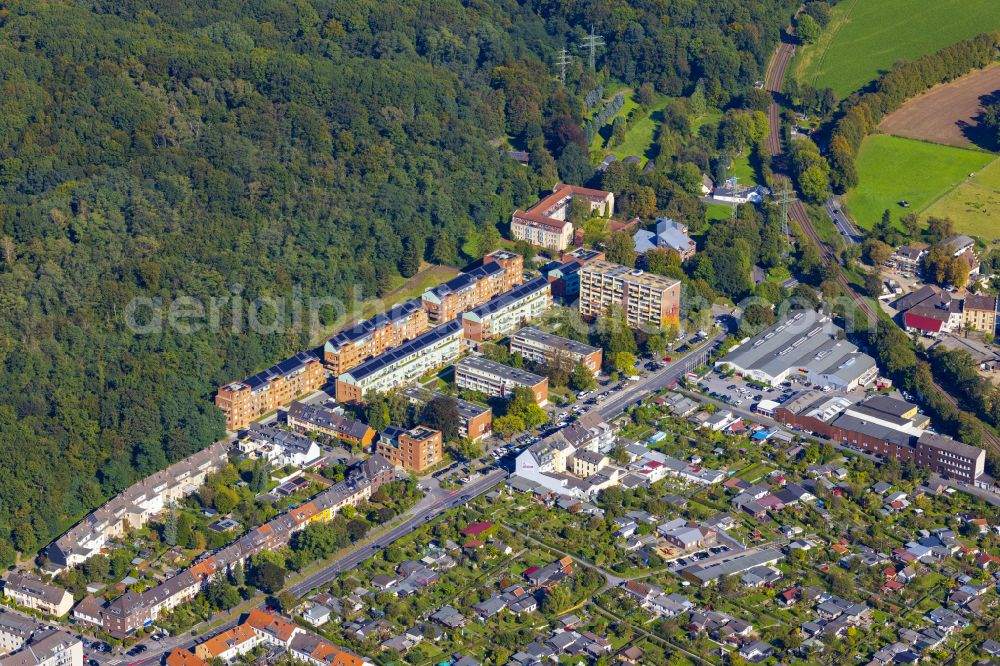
[0,0,793,562]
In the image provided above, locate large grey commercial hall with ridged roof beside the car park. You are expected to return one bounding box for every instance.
[715,312,878,391]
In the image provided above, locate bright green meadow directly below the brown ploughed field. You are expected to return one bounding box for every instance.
[847,134,995,229]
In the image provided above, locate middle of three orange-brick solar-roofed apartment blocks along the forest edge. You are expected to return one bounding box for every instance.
[323,298,428,376]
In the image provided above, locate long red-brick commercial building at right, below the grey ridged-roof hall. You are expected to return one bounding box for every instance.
[774,391,986,483]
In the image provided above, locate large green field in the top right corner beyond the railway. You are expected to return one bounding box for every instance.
[792,0,1000,98]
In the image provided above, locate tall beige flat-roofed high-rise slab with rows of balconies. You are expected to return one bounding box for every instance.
[580,261,681,329]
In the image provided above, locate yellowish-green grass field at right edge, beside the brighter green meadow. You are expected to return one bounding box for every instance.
[925,154,1000,241]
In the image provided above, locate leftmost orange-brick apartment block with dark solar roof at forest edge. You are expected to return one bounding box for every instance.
[215,352,324,432]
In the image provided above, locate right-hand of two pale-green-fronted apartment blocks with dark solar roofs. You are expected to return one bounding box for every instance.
[462,277,552,342]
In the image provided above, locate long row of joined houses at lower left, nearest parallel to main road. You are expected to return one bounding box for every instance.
[73,455,395,636]
